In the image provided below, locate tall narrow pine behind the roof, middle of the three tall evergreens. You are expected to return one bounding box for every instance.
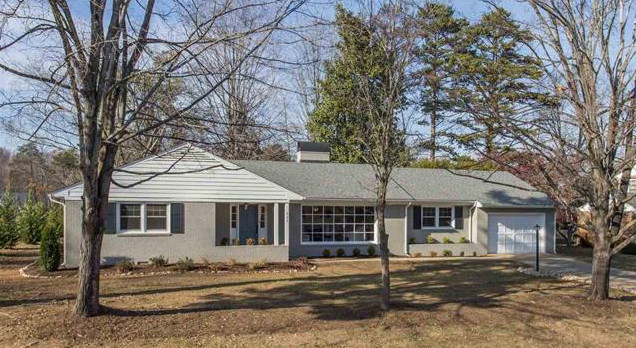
[414,2,468,161]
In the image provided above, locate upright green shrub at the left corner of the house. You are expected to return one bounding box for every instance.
[40,209,64,272]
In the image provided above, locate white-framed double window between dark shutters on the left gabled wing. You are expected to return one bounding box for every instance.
[117,203,170,233]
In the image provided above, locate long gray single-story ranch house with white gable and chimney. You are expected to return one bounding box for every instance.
[51,143,555,267]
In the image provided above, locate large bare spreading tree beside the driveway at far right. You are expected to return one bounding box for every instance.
[482,0,636,300]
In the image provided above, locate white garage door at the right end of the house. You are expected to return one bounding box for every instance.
[488,214,545,254]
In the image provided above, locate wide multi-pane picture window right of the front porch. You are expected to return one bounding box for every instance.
[302,205,375,244]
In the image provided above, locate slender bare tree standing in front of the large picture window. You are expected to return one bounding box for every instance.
[352,2,414,311]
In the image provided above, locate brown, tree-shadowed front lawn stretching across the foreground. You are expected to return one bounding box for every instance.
[0,249,636,347]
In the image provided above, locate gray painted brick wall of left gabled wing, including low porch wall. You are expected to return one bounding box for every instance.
[64,201,288,267]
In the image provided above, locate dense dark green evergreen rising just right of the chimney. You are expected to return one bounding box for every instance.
[307,5,408,163]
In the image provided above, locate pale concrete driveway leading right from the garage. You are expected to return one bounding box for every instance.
[508,254,636,293]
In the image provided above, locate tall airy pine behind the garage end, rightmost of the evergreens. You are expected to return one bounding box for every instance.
[454,8,549,158]
